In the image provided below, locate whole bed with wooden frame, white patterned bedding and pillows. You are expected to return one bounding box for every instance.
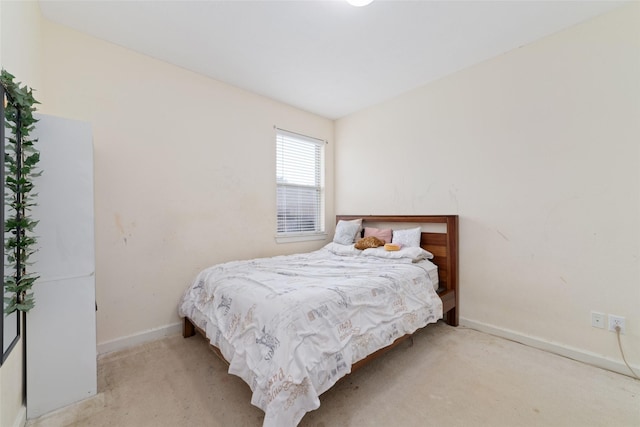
[179,215,459,427]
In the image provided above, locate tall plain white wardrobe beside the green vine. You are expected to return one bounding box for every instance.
[26,115,97,418]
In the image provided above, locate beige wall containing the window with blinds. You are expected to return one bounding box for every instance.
[38,22,334,344]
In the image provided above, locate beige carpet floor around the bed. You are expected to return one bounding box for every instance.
[27,323,640,427]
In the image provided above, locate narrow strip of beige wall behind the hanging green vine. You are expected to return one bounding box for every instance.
[0,1,43,427]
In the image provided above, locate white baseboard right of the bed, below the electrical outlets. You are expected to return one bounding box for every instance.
[460,317,640,376]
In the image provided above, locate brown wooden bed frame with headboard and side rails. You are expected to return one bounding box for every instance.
[182,215,459,372]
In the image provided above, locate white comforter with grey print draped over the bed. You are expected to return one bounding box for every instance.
[179,245,442,427]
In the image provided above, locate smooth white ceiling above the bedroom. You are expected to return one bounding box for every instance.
[40,0,623,119]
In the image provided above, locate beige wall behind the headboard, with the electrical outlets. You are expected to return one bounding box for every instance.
[335,3,640,372]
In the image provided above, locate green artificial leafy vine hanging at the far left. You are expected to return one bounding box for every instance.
[0,69,42,314]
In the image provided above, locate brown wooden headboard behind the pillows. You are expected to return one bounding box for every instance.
[336,215,459,326]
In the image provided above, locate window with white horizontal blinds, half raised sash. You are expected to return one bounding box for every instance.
[276,129,325,241]
